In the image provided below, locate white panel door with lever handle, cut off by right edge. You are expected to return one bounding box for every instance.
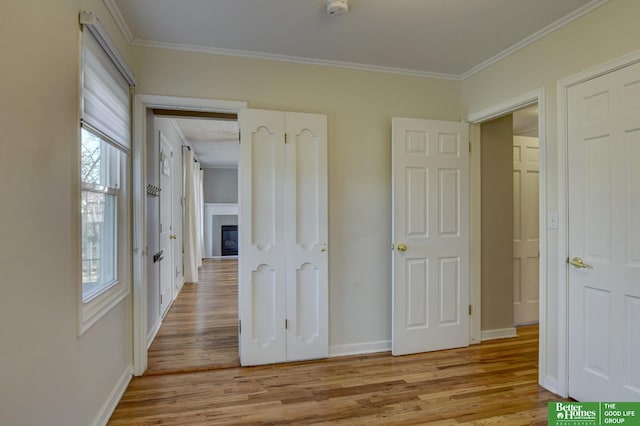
[568,64,640,401]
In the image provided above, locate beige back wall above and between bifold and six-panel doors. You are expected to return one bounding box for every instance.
[135,48,460,346]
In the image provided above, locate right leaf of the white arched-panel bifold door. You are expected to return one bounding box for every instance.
[284,112,329,360]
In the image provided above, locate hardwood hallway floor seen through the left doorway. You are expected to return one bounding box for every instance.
[145,259,240,376]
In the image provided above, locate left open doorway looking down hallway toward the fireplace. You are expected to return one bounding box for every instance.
[146,108,239,374]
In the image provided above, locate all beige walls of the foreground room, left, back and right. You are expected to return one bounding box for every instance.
[5,0,640,426]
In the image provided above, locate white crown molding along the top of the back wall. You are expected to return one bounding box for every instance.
[131,39,460,80]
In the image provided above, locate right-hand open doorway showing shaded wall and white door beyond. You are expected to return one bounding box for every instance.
[480,104,540,340]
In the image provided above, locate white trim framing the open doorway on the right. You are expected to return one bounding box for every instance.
[465,88,557,386]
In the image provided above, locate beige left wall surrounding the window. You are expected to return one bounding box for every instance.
[0,0,131,426]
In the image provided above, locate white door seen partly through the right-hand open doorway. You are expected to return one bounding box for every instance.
[513,136,540,325]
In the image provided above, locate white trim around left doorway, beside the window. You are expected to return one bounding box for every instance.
[132,94,247,376]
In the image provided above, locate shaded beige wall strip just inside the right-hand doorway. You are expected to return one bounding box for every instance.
[480,114,513,331]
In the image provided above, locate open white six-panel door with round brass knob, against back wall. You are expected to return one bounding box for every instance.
[392,118,469,355]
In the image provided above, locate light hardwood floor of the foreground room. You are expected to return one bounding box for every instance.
[109,265,562,426]
